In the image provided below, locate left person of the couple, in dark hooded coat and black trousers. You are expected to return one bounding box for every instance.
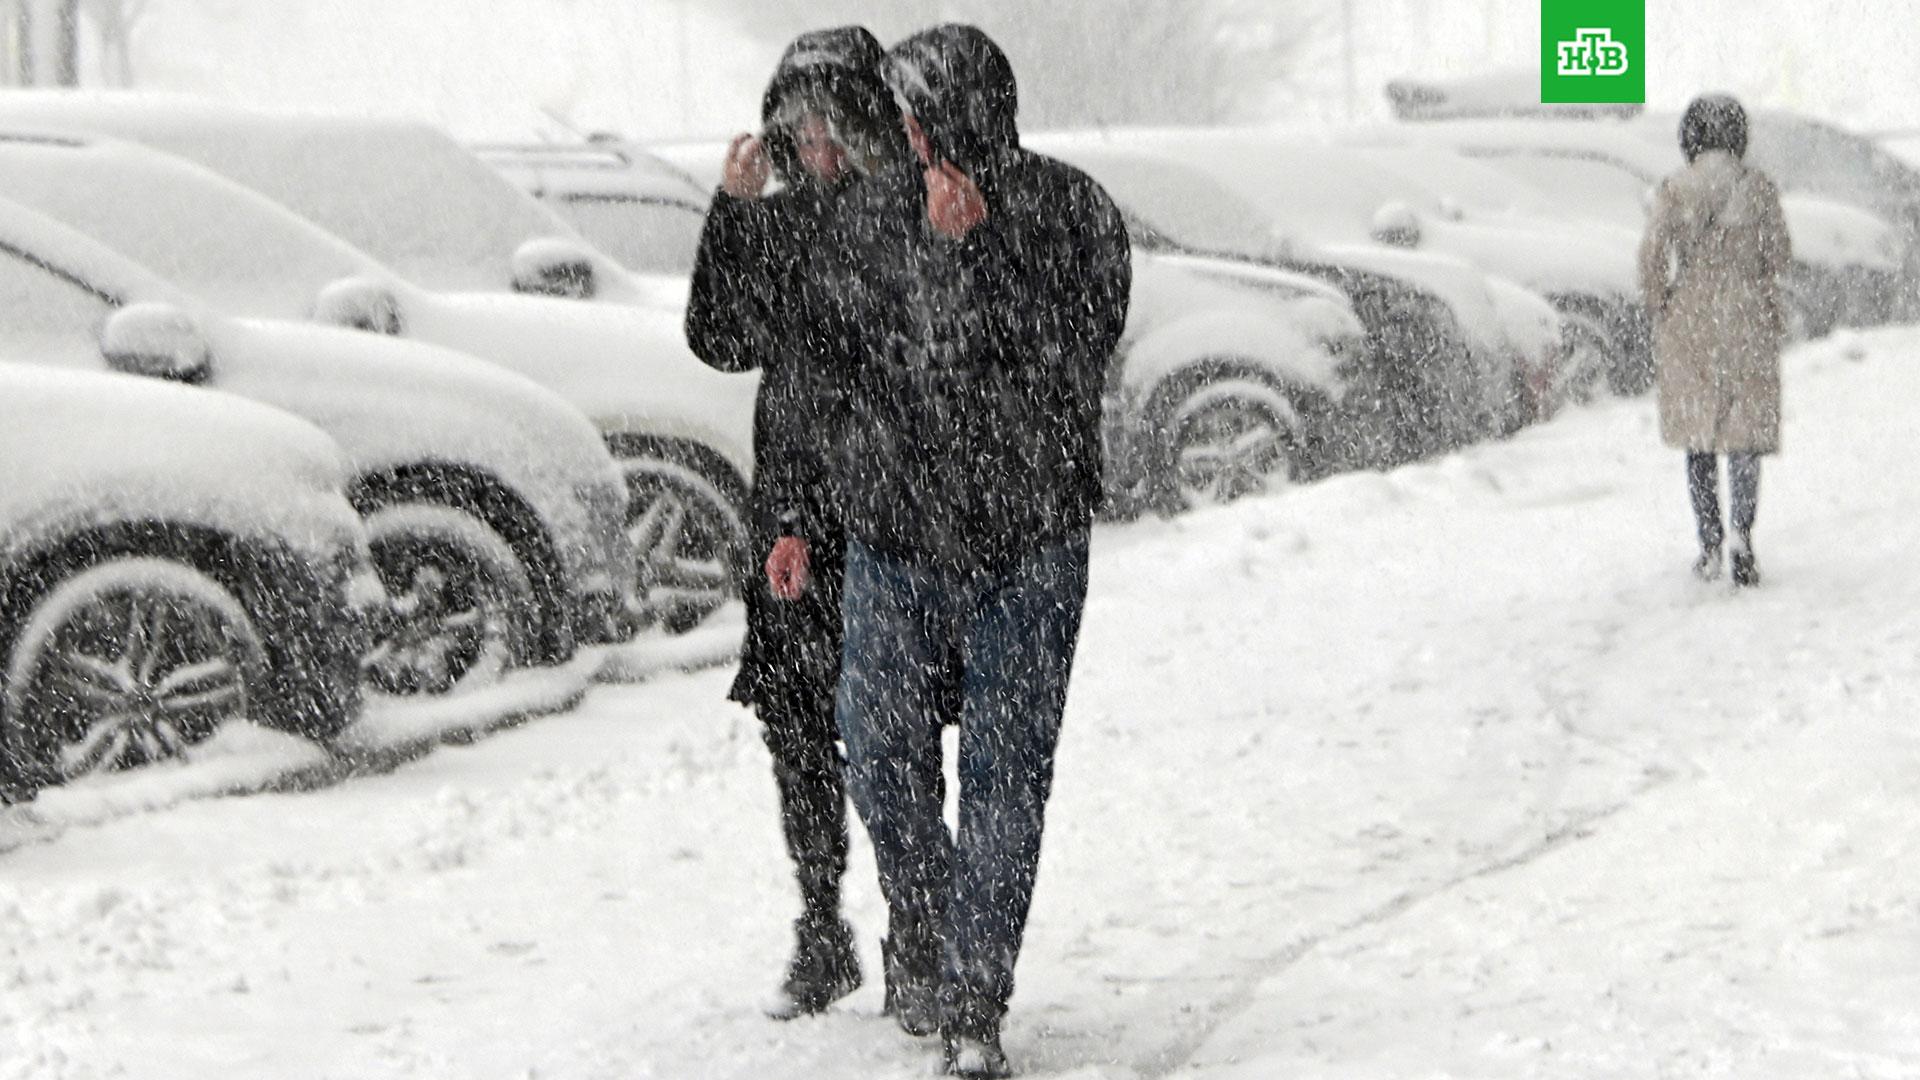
[687,27,908,1019]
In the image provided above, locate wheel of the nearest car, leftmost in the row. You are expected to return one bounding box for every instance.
[0,557,269,794]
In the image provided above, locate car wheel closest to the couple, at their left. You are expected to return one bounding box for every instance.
[620,457,747,634]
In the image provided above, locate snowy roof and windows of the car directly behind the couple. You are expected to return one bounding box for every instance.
[472,138,710,275]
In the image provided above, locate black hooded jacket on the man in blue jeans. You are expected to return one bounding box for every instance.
[816,25,1131,569]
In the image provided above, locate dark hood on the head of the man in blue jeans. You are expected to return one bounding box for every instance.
[887,23,1020,173]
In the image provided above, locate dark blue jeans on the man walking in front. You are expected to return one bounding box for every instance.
[837,536,1087,1028]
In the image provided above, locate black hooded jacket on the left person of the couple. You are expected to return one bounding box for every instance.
[685,27,910,546]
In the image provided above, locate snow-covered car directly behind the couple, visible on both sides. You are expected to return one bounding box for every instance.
[480,134,1380,517]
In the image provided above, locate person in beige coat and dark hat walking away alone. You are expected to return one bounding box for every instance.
[1640,94,1791,586]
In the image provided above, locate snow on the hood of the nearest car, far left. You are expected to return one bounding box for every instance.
[0,365,365,559]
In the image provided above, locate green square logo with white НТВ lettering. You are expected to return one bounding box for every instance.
[1540,0,1647,104]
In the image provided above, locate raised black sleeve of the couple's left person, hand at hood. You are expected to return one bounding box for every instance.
[687,192,787,371]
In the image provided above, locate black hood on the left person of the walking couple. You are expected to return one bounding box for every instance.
[760,27,912,184]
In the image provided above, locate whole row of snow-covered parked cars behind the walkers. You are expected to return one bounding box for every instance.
[0,92,1920,799]
